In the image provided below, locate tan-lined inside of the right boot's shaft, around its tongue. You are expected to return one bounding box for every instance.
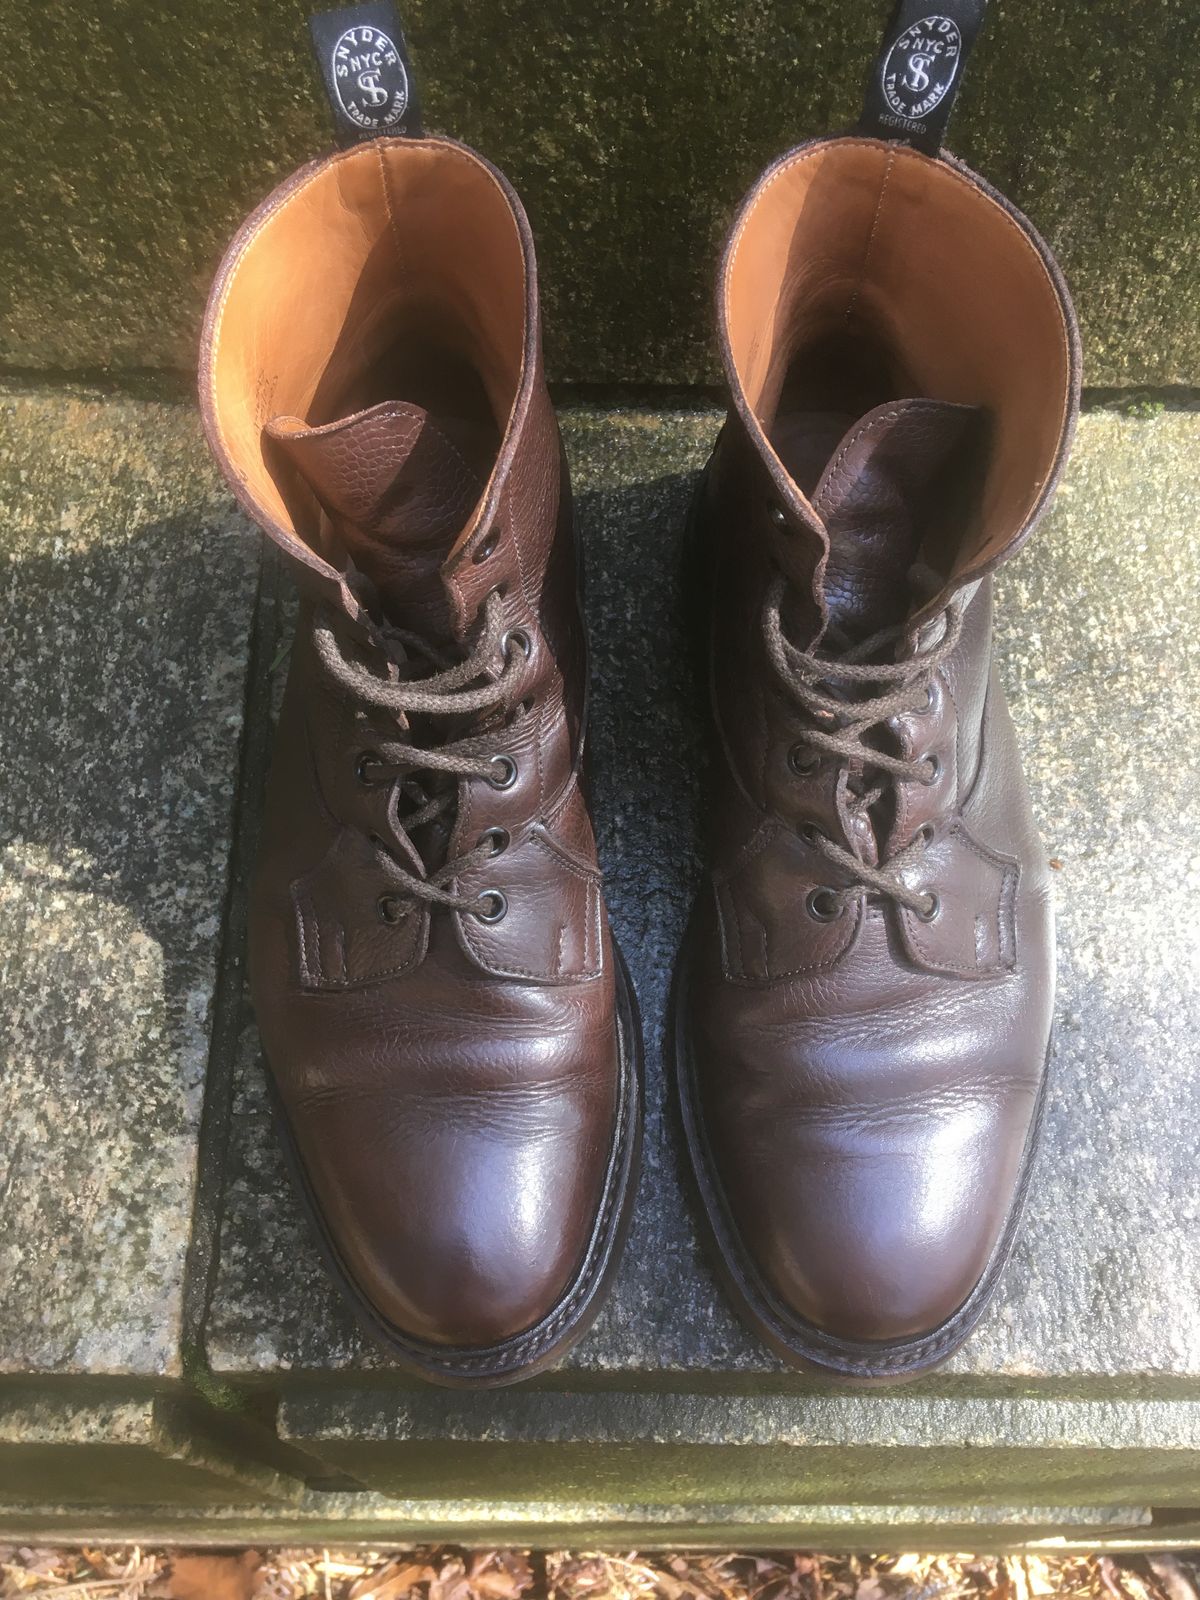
[717,138,1080,621]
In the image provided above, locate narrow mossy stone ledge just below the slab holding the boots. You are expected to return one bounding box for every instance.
[280,1390,1200,1514]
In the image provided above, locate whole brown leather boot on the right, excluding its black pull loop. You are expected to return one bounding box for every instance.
[677,128,1078,1379]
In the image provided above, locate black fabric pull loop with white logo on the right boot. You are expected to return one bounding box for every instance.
[858,0,987,155]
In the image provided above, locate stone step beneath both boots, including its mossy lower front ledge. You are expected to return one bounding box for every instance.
[206,403,1200,1542]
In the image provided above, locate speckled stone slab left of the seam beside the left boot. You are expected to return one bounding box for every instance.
[0,394,259,1382]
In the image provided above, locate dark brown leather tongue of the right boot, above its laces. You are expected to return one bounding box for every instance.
[776,400,979,638]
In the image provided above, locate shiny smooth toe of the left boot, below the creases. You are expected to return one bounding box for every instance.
[293,1093,608,1349]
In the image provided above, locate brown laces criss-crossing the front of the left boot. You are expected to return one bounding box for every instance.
[314,590,528,922]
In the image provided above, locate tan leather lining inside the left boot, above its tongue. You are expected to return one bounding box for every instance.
[206,139,526,533]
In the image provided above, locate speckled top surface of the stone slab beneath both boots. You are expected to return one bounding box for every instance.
[206,411,1200,1408]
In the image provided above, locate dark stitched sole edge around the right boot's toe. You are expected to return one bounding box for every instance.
[670,915,1053,1387]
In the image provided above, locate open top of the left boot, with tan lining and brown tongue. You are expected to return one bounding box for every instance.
[200,138,560,637]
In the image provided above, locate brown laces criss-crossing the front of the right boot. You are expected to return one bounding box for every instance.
[763,574,963,918]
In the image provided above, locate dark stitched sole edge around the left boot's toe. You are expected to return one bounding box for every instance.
[267,941,642,1389]
